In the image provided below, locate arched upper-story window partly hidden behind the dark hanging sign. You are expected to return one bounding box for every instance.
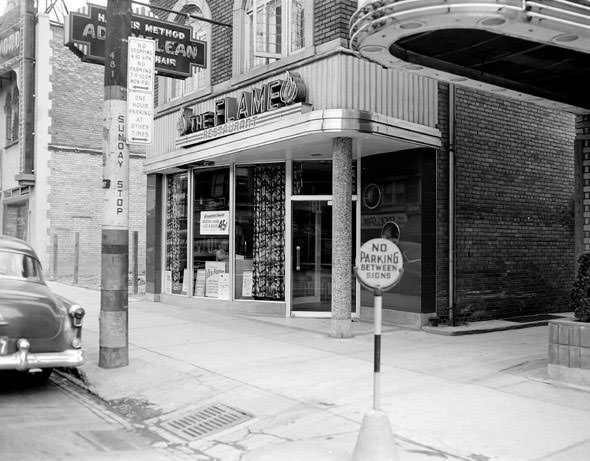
[158,0,211,104]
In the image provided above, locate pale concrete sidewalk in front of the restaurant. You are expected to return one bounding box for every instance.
[49,282,590,461]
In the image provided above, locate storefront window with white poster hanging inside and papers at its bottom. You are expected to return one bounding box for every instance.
[193,168,231,299]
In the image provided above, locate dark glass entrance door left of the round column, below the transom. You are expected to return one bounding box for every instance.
[291,200,332,312]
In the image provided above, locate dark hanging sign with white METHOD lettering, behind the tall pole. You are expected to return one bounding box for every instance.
[65,5,207,78]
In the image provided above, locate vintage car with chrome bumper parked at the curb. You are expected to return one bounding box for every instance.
[0,236,84,381]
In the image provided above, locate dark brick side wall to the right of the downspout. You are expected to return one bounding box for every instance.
[439,87,575,319]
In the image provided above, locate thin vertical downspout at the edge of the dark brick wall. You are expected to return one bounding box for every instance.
[449,83,455,326]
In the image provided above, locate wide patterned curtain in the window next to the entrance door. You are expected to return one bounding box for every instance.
[252,165,285,300]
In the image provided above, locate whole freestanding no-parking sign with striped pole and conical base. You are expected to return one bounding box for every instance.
[352,238,404,461]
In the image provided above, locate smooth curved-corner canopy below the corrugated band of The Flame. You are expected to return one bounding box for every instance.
[145,103,441,174]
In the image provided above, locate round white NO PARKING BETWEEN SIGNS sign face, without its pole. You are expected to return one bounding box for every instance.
[355,238,404,291]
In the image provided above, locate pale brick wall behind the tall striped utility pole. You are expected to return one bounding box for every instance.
[46,26,146,285]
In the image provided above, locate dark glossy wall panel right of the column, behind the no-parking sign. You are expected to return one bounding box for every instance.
[361,151,423,312]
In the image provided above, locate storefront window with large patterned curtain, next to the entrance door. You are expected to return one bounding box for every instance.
[235,164,285,301]
